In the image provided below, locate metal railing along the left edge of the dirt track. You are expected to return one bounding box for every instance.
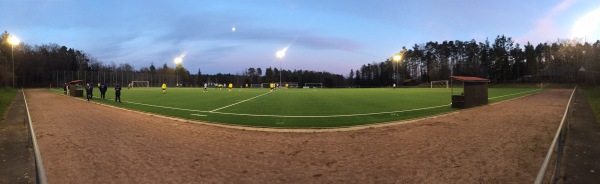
[21,88,48,184]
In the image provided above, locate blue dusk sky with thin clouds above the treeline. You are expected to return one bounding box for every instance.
[0,0,600,75]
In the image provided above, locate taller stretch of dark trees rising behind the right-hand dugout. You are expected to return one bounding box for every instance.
[347,35,600,86]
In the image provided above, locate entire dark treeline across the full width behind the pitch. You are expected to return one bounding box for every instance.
[0,31,600,87]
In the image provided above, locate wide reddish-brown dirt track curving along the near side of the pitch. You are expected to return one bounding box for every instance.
[26,90,571,183]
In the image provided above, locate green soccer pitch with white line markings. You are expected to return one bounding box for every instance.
[50,88,539,128]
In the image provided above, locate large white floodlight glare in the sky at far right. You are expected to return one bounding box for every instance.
[571,8,600,40]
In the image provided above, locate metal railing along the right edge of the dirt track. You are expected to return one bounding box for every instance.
[535,86,577,184]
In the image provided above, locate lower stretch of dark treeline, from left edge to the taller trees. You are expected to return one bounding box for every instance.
[0,31,346,87]
